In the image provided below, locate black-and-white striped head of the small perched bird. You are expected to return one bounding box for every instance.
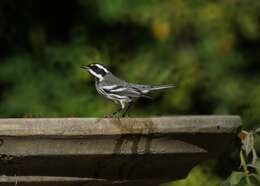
[81,63,109,80]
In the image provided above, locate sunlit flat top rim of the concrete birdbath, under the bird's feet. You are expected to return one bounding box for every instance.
[0,116,241,137]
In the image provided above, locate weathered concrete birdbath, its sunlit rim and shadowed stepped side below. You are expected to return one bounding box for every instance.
[0,116,241,185]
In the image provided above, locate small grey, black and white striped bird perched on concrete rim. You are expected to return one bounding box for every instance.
[81,63,175,117]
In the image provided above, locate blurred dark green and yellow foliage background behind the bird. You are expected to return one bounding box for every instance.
[0,0,260,186]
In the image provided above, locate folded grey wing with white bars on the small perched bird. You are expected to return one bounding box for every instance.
[102,85,151,98]
